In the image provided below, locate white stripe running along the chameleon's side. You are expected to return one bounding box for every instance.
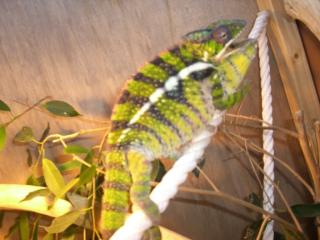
[117,62,214,143]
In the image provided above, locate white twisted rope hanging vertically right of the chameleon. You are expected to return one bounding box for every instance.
[249,12,274,240]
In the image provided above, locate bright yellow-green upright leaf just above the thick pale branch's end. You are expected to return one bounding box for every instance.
[42,158,65,195]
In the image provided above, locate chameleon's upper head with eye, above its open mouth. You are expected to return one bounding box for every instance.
[183,19,246,60]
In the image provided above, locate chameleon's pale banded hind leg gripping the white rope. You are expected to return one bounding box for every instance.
[127,150,160,224]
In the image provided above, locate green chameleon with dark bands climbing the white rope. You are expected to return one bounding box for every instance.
[100,20,256,239]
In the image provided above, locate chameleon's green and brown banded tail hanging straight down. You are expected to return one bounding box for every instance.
[100,150,131,239]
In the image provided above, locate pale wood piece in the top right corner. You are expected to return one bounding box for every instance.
[284,0,320,40]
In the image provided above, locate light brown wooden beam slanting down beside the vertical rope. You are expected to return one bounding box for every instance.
[257,0,320,139]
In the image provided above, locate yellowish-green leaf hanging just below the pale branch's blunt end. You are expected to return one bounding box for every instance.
[45,210,85,234]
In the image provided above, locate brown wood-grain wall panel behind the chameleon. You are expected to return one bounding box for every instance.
[0,0,316,240]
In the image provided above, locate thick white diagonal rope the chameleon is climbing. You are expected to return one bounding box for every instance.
[111,13,267,240]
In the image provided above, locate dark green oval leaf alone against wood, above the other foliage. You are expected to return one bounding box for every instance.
[42,100,80,117]
